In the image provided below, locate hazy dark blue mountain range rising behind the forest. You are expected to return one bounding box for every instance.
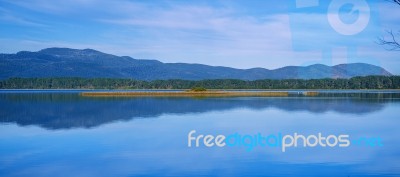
[0,48,392,80]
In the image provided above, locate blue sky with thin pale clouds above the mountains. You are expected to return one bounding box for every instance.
[0,0,400,74]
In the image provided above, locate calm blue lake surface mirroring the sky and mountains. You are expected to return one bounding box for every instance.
[0,90,400,177]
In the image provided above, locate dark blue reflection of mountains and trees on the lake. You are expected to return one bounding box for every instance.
[0,93,400,129]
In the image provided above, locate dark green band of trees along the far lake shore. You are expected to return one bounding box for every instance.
[0,76,400,89]
